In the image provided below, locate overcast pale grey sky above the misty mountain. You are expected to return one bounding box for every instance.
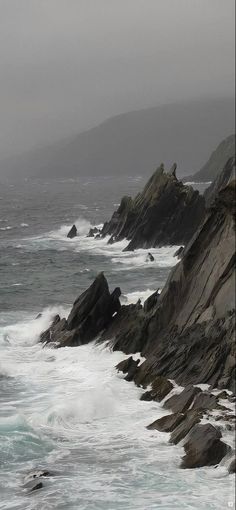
[0,0,234,158]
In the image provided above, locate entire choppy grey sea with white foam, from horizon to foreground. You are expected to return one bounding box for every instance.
[0,177,233,510]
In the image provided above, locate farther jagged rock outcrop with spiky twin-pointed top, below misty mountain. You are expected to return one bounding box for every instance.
[101,165,205,250]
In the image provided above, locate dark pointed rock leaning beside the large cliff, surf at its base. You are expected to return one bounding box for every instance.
[40,273,121,347]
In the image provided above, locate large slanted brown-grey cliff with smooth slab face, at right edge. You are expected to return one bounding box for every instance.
[103,181,235,391]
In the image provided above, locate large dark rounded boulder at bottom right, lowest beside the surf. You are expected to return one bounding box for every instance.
[180,424,230,469]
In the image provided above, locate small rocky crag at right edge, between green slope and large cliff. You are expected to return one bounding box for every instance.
[204,157,235,208]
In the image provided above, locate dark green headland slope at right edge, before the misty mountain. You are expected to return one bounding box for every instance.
[184,135,235,182]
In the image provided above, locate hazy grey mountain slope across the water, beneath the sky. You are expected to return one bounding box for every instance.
[0,99,234,177]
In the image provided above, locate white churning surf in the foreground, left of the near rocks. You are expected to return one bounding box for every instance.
[0,309,233,510]
